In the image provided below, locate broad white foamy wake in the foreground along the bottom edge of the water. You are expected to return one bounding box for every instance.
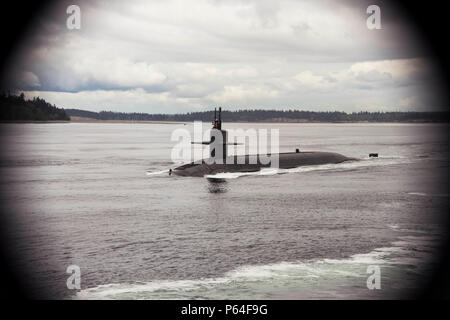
[75,226,437,299]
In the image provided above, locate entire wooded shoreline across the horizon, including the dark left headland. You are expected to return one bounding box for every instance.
[0,93,450,122]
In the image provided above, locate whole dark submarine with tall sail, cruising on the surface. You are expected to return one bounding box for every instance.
[169,108,356,177]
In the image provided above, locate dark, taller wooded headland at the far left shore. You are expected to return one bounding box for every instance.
[0,93,70,121]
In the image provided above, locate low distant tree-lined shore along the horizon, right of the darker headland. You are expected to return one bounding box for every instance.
[66,109,449,122]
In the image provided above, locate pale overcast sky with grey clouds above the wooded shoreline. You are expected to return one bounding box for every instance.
[3,0,445,113]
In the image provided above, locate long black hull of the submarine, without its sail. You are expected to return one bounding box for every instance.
[172,151,355,177]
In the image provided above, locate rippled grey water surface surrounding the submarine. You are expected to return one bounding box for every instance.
[0,123,450,299]
